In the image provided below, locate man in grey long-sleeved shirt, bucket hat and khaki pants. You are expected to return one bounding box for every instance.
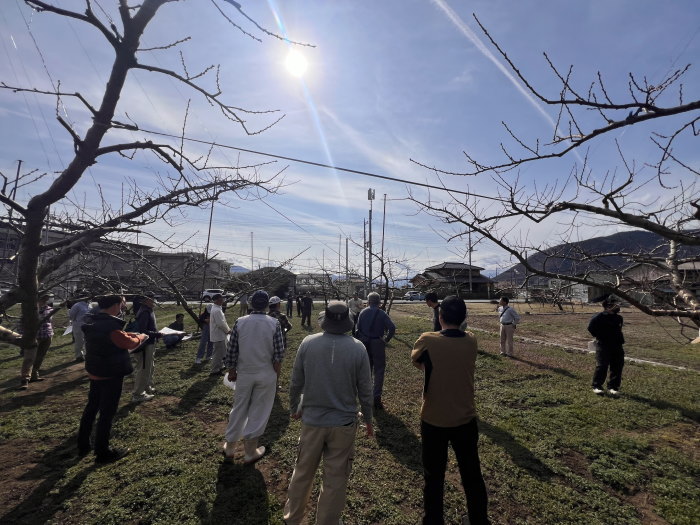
[284,301,374,525]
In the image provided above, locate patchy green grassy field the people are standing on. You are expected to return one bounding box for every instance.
[0,304,700,525]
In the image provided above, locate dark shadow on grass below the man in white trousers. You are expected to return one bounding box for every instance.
[202,456,270,525]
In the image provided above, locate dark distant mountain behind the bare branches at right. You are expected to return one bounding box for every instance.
[494,230,700,283]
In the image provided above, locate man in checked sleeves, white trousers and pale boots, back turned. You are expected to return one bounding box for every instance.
[224,290,284,463]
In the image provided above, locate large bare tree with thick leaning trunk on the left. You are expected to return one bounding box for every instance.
[0,0,302,354]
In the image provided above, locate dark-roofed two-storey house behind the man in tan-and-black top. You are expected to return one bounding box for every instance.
[410,262,494,299]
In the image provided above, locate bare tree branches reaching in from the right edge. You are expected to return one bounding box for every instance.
[413,17,700,340]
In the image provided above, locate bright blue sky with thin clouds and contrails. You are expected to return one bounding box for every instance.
[0,0,700,274]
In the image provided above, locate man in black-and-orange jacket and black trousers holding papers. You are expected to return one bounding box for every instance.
[78,295,148,463]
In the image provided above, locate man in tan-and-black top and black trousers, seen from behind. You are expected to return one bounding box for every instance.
[411,295,489,525]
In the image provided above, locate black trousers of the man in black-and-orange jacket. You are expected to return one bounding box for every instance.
[78,376,124,456]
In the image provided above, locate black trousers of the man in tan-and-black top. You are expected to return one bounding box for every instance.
[421,418,489,525]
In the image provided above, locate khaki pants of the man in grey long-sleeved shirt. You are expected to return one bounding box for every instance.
[284,423,357,525]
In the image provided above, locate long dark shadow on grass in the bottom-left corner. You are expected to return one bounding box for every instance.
[0,436,97,523]
